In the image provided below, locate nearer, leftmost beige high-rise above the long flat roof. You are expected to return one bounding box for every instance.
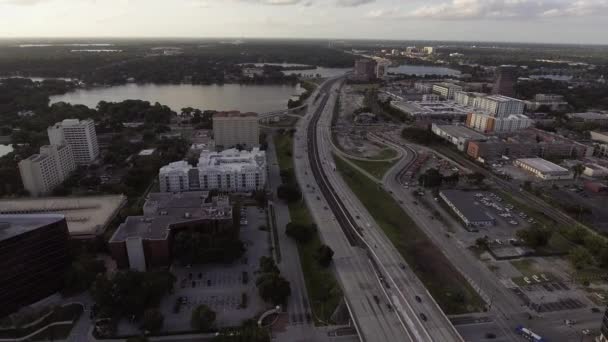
[19,145,76,196]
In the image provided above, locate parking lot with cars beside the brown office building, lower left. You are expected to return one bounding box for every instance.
[161,207,270,331]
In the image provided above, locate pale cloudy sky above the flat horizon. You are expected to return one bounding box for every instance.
[0,0,608,44]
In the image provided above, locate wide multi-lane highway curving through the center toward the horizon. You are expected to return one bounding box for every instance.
[294,76,462,341]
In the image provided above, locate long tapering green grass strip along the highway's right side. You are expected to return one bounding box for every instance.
[336,158,484,314]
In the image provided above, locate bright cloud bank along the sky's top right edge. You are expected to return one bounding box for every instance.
[367,0,608,20]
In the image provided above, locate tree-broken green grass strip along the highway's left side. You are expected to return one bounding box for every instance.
[274,134,343,324]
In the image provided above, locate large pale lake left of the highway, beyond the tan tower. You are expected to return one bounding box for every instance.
[51,84,304,113]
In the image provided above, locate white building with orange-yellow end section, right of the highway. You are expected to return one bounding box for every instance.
[466,113,534,133]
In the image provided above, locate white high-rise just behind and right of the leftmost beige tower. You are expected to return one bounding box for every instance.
[47,119,99,165]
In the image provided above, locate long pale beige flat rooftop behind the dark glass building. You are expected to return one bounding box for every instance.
[0,195,127,236]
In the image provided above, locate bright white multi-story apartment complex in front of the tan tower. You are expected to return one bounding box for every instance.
[158,148,266,192]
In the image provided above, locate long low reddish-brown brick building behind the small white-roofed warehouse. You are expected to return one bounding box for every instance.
[467,128,594,160]
